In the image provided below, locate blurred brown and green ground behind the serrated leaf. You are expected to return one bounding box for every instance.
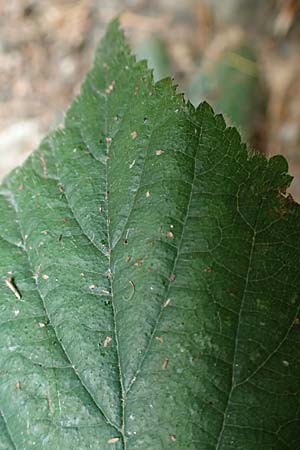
[0,0,300,197]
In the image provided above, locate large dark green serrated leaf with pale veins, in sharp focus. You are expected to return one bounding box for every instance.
[0,17,300,450]
